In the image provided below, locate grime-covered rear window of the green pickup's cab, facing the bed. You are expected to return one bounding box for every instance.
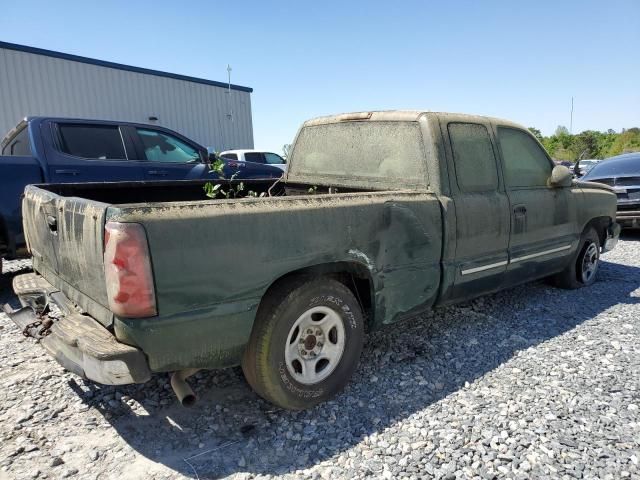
[290,122,426,187]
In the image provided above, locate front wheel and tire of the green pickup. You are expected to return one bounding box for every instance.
[553,227,600,289]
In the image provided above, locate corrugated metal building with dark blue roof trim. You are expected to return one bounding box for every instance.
[0,42,253,151]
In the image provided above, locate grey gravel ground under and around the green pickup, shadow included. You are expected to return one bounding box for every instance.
[0,234,640,480]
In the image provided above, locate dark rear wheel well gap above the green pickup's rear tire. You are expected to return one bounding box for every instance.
[261,262,375,329]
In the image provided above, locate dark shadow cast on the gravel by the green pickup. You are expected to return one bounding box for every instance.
[21,258,640,479]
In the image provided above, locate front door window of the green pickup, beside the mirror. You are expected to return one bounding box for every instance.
[498,127,553,188]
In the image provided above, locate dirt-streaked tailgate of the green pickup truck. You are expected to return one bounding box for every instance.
[22,186,111,325]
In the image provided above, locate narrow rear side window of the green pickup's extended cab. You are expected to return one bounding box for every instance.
[447,123,498,193]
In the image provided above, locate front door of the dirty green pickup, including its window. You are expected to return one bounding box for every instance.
[496,125,580,284]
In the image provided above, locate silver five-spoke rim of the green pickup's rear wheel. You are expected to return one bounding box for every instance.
[284,307,346,385]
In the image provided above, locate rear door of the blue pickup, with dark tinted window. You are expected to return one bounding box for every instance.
[42,122,144,183]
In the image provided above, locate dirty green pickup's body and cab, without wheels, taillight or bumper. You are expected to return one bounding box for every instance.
[18,112,616,371]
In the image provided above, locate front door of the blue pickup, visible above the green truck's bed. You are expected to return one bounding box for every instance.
[133,128,211,181]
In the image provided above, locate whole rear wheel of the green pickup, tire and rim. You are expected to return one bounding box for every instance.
[242,277,364,410]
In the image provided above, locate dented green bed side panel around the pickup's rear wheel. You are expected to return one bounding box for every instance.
[107,192,442,370]
